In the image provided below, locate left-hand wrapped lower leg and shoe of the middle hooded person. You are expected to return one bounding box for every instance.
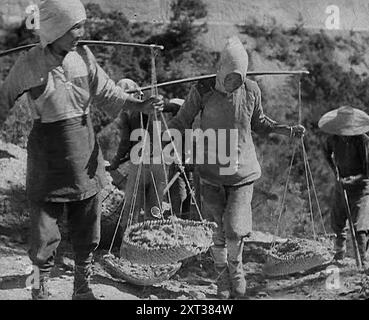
[211,246,231,299]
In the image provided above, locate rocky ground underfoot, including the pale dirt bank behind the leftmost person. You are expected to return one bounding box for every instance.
[0,141,369,300]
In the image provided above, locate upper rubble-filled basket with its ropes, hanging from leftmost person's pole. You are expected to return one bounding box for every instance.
[121,48,216,265]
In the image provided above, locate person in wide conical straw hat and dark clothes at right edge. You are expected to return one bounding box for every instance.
[318,106,369,269]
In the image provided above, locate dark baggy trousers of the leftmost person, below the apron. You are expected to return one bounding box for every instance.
[29,193,101,272]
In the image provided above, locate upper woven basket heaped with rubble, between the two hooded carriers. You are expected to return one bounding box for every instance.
[120,218,216,265]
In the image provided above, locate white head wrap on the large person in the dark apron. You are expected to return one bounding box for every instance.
[38,0,86,47]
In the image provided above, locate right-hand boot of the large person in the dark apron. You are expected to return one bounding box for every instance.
[72,265,98,300]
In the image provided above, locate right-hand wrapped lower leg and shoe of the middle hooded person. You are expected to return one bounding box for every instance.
[227,239,246,298]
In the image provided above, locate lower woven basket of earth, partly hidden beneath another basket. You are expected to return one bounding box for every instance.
[101,255,182,286]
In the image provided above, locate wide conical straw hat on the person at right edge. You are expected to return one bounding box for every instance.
[318,106,369,136]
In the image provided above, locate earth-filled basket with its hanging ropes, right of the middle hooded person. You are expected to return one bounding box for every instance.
[263,77,331,276]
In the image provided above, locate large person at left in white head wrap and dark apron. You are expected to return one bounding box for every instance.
[0,0,162,299]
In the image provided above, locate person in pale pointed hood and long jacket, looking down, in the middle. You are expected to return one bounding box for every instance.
[169,37,305,299]
